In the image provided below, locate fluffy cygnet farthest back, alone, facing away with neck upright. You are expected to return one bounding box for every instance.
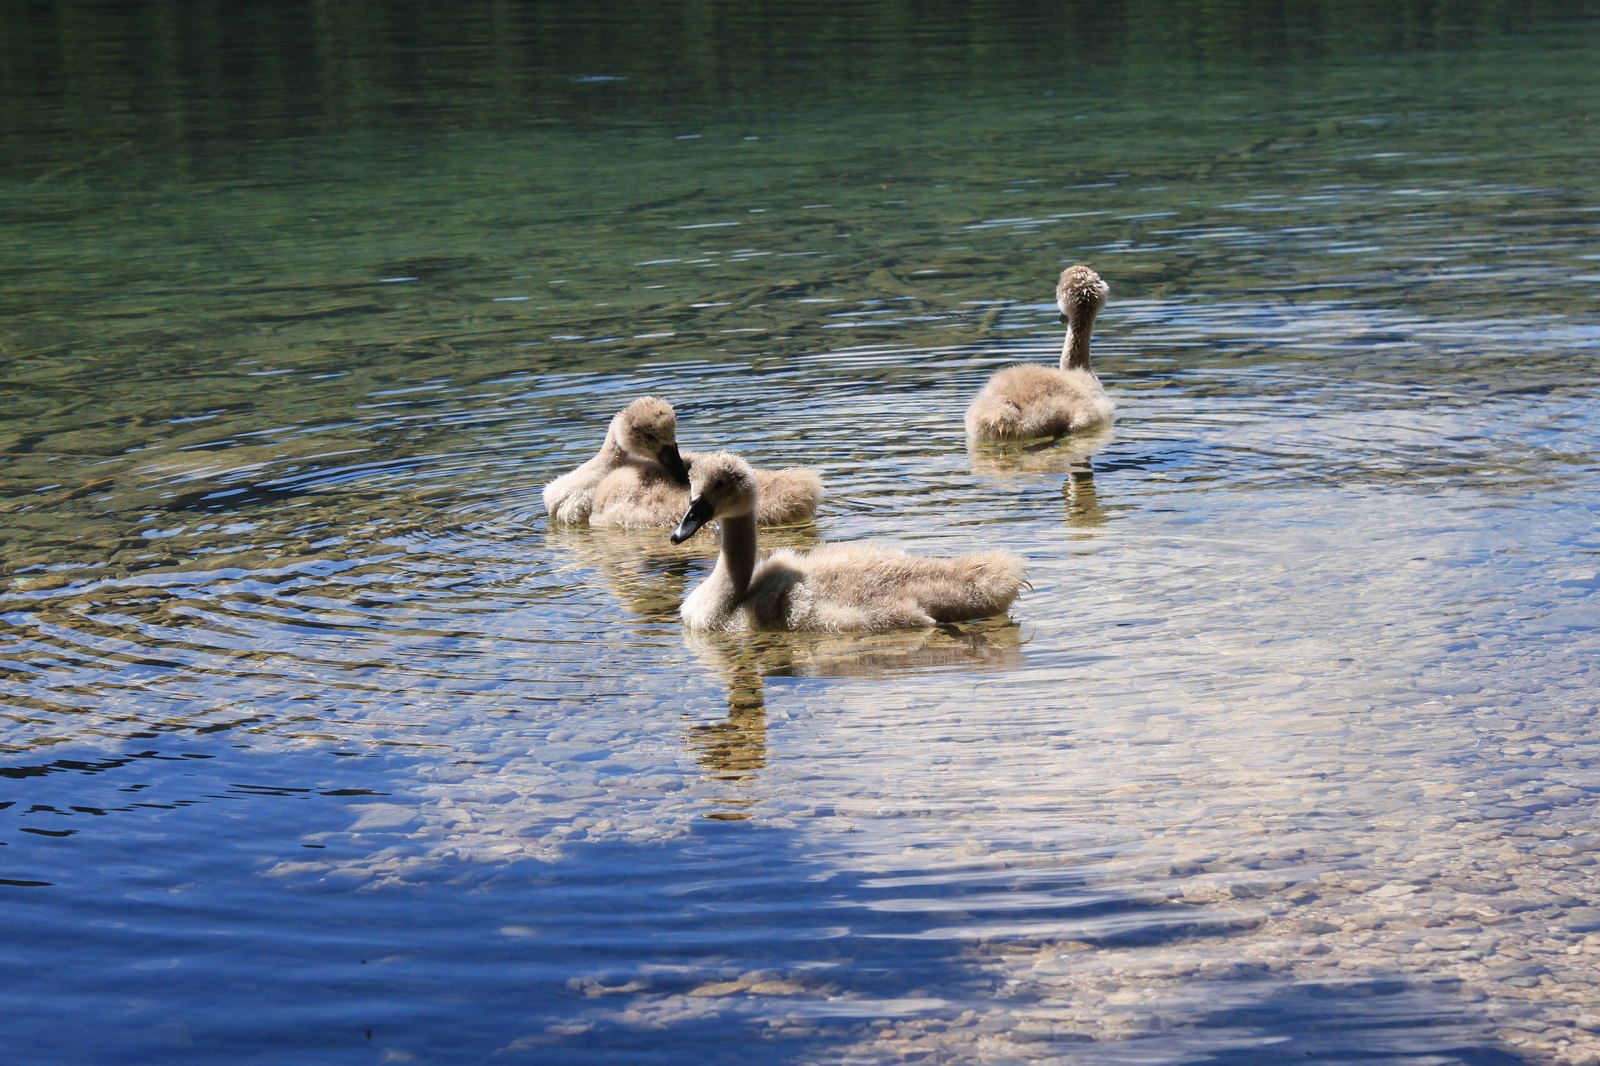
[966,266,1115,442]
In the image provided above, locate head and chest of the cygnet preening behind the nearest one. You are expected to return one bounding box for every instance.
[544,395,690,525]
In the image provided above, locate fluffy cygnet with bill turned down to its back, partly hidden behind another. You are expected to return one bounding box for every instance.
[544,397,822,530]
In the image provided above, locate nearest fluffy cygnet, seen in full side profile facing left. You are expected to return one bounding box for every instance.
[672,451,1022,632]
